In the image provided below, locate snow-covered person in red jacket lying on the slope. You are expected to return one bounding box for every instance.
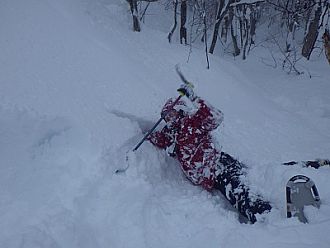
[148,84,271,223]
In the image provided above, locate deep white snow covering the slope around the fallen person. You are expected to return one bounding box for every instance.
[0,0,330,248]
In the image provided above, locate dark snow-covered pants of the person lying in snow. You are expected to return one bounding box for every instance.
[215,152,272,223]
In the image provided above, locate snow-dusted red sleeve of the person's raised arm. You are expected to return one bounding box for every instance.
[193,97,223,131]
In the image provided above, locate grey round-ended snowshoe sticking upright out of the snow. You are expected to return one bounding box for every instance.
[286,175,321,223]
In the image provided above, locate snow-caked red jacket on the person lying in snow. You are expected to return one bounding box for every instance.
[148,98,223,190]
